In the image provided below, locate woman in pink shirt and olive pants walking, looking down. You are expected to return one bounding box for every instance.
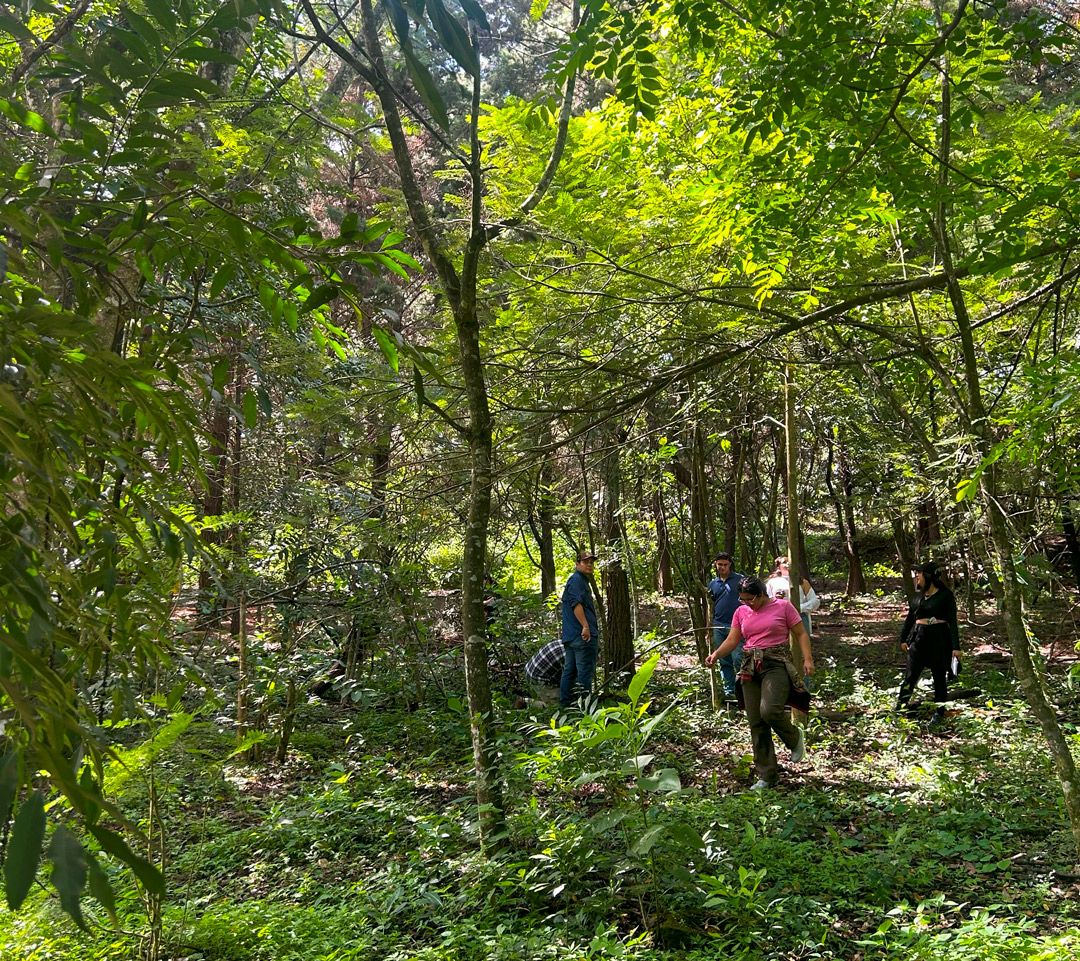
[705,578,814,790]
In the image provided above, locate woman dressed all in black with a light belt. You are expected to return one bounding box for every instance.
[896,560,960,727]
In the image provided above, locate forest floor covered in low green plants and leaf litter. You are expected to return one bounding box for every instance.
[0,578,1080,961]
